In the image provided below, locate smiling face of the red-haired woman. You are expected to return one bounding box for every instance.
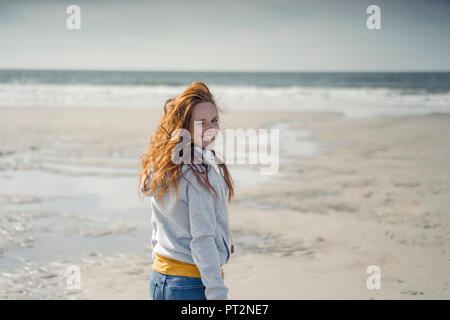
[189,102,219,148]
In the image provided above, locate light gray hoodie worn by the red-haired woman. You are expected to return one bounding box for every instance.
[142,149,232,300]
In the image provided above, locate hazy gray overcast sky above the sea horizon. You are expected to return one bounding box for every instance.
[0,0,450,71]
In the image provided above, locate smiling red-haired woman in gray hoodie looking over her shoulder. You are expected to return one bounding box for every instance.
[139,82,233,300]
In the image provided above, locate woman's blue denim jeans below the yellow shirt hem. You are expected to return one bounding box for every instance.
[150,269,206,300]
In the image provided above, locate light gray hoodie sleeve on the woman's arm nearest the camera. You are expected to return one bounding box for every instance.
[187,171,228,300]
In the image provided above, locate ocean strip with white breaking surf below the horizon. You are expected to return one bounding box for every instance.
[0,70,450,118]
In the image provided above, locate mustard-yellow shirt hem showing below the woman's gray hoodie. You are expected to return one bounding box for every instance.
[152,254,224,278]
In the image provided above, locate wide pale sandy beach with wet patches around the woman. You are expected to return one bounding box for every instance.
[0,108,450,299]
